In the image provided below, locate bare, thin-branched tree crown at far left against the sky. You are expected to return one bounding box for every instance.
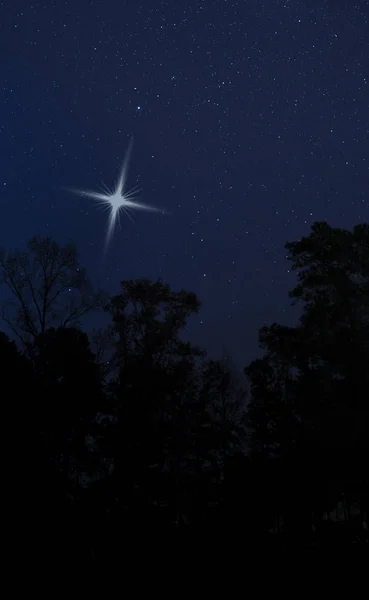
[0,236,106,347]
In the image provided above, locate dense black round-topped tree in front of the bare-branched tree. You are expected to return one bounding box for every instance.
[23,327,104,560]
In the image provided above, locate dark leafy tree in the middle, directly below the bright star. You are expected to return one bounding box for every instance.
[103,279,207,532]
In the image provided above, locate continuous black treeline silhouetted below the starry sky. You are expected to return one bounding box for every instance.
[0,222,369,562]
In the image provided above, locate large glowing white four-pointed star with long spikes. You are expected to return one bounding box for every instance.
[66,140,164,248]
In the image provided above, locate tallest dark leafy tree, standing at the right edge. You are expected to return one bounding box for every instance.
[246,223,369,544]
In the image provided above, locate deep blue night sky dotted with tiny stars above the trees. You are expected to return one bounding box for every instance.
[0,0,369,365]
